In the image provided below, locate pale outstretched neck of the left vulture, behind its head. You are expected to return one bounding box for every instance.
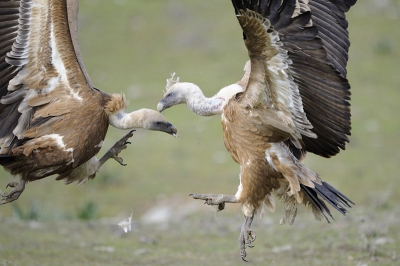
[109,109,149,129]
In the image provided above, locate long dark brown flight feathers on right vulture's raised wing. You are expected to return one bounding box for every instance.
[234,0,356,157]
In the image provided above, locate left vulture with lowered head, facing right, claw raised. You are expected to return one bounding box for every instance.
[0,0,177,204]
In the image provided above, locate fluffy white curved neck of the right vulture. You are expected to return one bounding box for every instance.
[180,83,225,116]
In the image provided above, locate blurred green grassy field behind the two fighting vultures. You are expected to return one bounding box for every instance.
[0,0,400,266]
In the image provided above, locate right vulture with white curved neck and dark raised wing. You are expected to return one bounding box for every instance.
[157,0,356,260]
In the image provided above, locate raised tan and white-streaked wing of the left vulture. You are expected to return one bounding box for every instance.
[0,0,93,153]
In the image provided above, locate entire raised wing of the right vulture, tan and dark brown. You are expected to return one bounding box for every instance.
[232,0,355,157]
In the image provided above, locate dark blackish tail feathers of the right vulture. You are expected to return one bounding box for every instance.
[300,181,354,223]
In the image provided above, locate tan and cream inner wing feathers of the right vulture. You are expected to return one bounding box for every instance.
[231,3,315,143]
